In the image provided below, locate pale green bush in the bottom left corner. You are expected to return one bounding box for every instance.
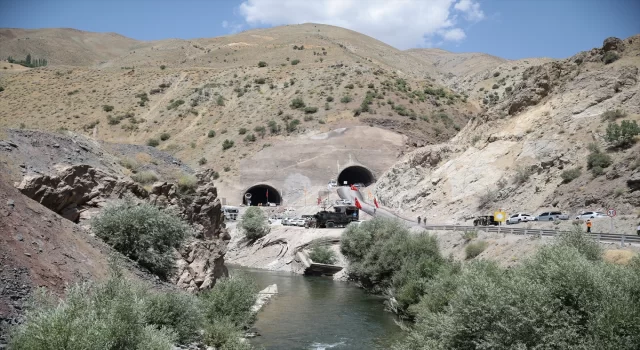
[10,268,180,350]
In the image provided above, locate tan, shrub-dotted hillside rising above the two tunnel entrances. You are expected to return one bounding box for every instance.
[0,24,478,180]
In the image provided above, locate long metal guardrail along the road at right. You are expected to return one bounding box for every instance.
[421,225,640,244]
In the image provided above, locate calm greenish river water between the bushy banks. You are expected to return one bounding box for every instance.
[231,267,400,350]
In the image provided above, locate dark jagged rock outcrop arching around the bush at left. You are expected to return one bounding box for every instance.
[17,165,229,290]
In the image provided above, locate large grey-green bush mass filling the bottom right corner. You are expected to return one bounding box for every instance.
[394,233,640,350]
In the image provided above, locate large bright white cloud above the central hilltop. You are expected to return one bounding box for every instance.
[239,0,484,49]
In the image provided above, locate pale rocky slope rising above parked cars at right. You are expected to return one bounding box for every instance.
[375,36,640,223]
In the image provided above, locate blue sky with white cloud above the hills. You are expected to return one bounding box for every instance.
[0,0,640,59]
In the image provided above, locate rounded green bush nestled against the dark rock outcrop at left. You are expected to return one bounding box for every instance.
[91,200,191,280]
